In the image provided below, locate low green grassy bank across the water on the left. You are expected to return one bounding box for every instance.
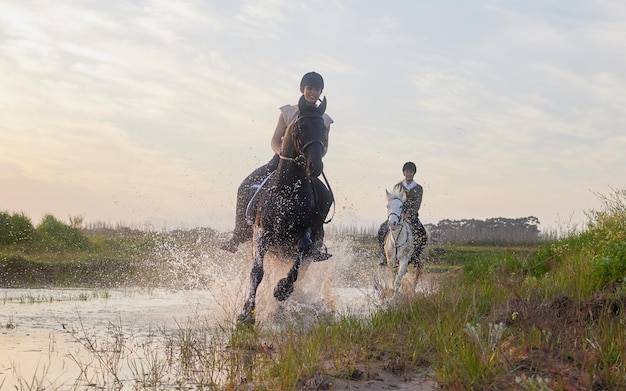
[0,227,219,288]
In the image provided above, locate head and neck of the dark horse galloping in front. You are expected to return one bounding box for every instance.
[281,96,328,177]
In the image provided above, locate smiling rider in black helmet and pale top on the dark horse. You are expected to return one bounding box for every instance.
[221,72,333,253]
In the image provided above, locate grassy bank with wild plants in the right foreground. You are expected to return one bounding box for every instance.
[225,192,626,390]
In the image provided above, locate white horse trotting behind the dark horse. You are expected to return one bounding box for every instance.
[385,190,419,296]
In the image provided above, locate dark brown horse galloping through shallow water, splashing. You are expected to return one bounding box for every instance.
[239,97,332,323]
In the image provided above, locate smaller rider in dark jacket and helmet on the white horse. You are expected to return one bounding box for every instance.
[378,162,428,268]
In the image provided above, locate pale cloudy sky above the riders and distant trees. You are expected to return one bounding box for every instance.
[0,0,626,231]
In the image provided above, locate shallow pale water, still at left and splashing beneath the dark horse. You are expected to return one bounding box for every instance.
[0,239,432,390]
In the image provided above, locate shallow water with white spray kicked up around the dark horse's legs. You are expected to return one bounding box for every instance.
[0,232,434,389]
